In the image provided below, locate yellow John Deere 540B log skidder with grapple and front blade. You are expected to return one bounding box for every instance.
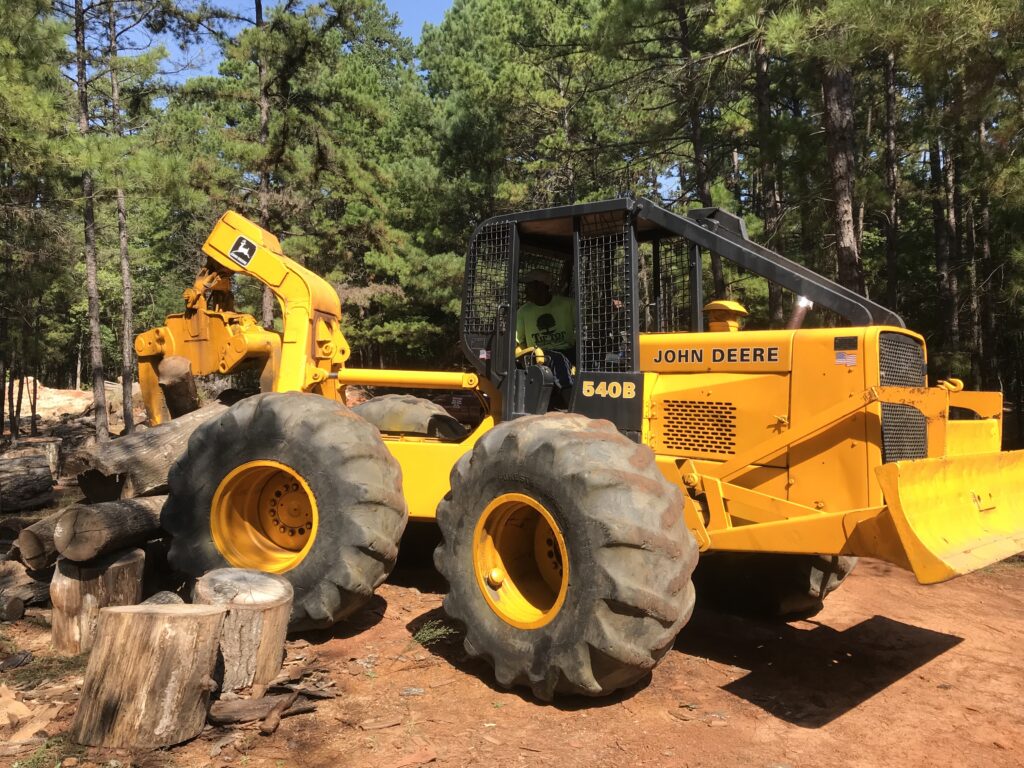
[136,199,1024,698]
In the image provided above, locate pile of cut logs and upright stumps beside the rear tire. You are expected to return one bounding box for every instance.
[0,391,323,749]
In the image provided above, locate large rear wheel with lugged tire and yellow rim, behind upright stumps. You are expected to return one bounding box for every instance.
[161,392,408,630]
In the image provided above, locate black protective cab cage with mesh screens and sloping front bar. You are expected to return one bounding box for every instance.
[462,198,903,384]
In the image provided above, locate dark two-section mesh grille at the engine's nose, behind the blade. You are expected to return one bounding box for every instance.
[879,333,928,463]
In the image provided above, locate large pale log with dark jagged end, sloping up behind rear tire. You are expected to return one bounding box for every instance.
[79,402,227,503]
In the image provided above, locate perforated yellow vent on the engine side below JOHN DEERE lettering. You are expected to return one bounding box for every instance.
[655,400,736,454]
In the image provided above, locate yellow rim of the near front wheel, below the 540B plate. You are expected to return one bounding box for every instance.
[473,494,569,630]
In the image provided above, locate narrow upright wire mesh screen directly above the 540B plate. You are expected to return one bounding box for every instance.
[577,211,635,373]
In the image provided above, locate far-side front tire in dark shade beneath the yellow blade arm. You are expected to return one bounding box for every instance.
[693,552,857,618]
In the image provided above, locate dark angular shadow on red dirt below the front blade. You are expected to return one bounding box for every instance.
[675,609,963,728]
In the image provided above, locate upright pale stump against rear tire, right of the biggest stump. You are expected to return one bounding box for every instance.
[193,568,292,693]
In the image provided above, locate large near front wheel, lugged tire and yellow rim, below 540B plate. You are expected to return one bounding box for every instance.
[434,413,697,700]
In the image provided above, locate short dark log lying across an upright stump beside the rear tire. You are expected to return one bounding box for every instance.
[53,496,167,562]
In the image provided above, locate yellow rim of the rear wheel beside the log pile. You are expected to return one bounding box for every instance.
[210,461,318,573]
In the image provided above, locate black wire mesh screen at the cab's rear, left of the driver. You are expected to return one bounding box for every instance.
[462,222,515,368]
